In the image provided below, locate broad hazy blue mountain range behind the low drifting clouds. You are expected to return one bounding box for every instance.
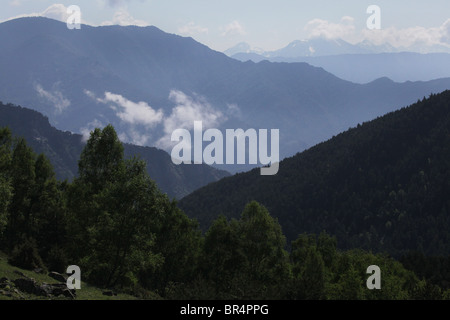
[0,18,450,172]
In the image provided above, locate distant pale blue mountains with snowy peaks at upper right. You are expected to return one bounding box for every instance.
[229,38,450,83]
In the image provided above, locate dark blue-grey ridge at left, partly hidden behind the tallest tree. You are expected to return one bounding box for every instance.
[0,102,229,199]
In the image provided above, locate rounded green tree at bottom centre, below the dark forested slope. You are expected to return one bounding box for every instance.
[196,202,290,299]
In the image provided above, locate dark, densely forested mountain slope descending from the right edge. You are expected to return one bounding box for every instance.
[179,91,450,256]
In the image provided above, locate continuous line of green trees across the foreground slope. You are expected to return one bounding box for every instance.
[0,126,450,299]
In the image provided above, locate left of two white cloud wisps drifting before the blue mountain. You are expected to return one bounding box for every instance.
[96,90,164,128]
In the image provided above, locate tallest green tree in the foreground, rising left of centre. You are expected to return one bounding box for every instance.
[69,126,163,287]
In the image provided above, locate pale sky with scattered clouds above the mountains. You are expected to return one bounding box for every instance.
[0,0,450,51]
